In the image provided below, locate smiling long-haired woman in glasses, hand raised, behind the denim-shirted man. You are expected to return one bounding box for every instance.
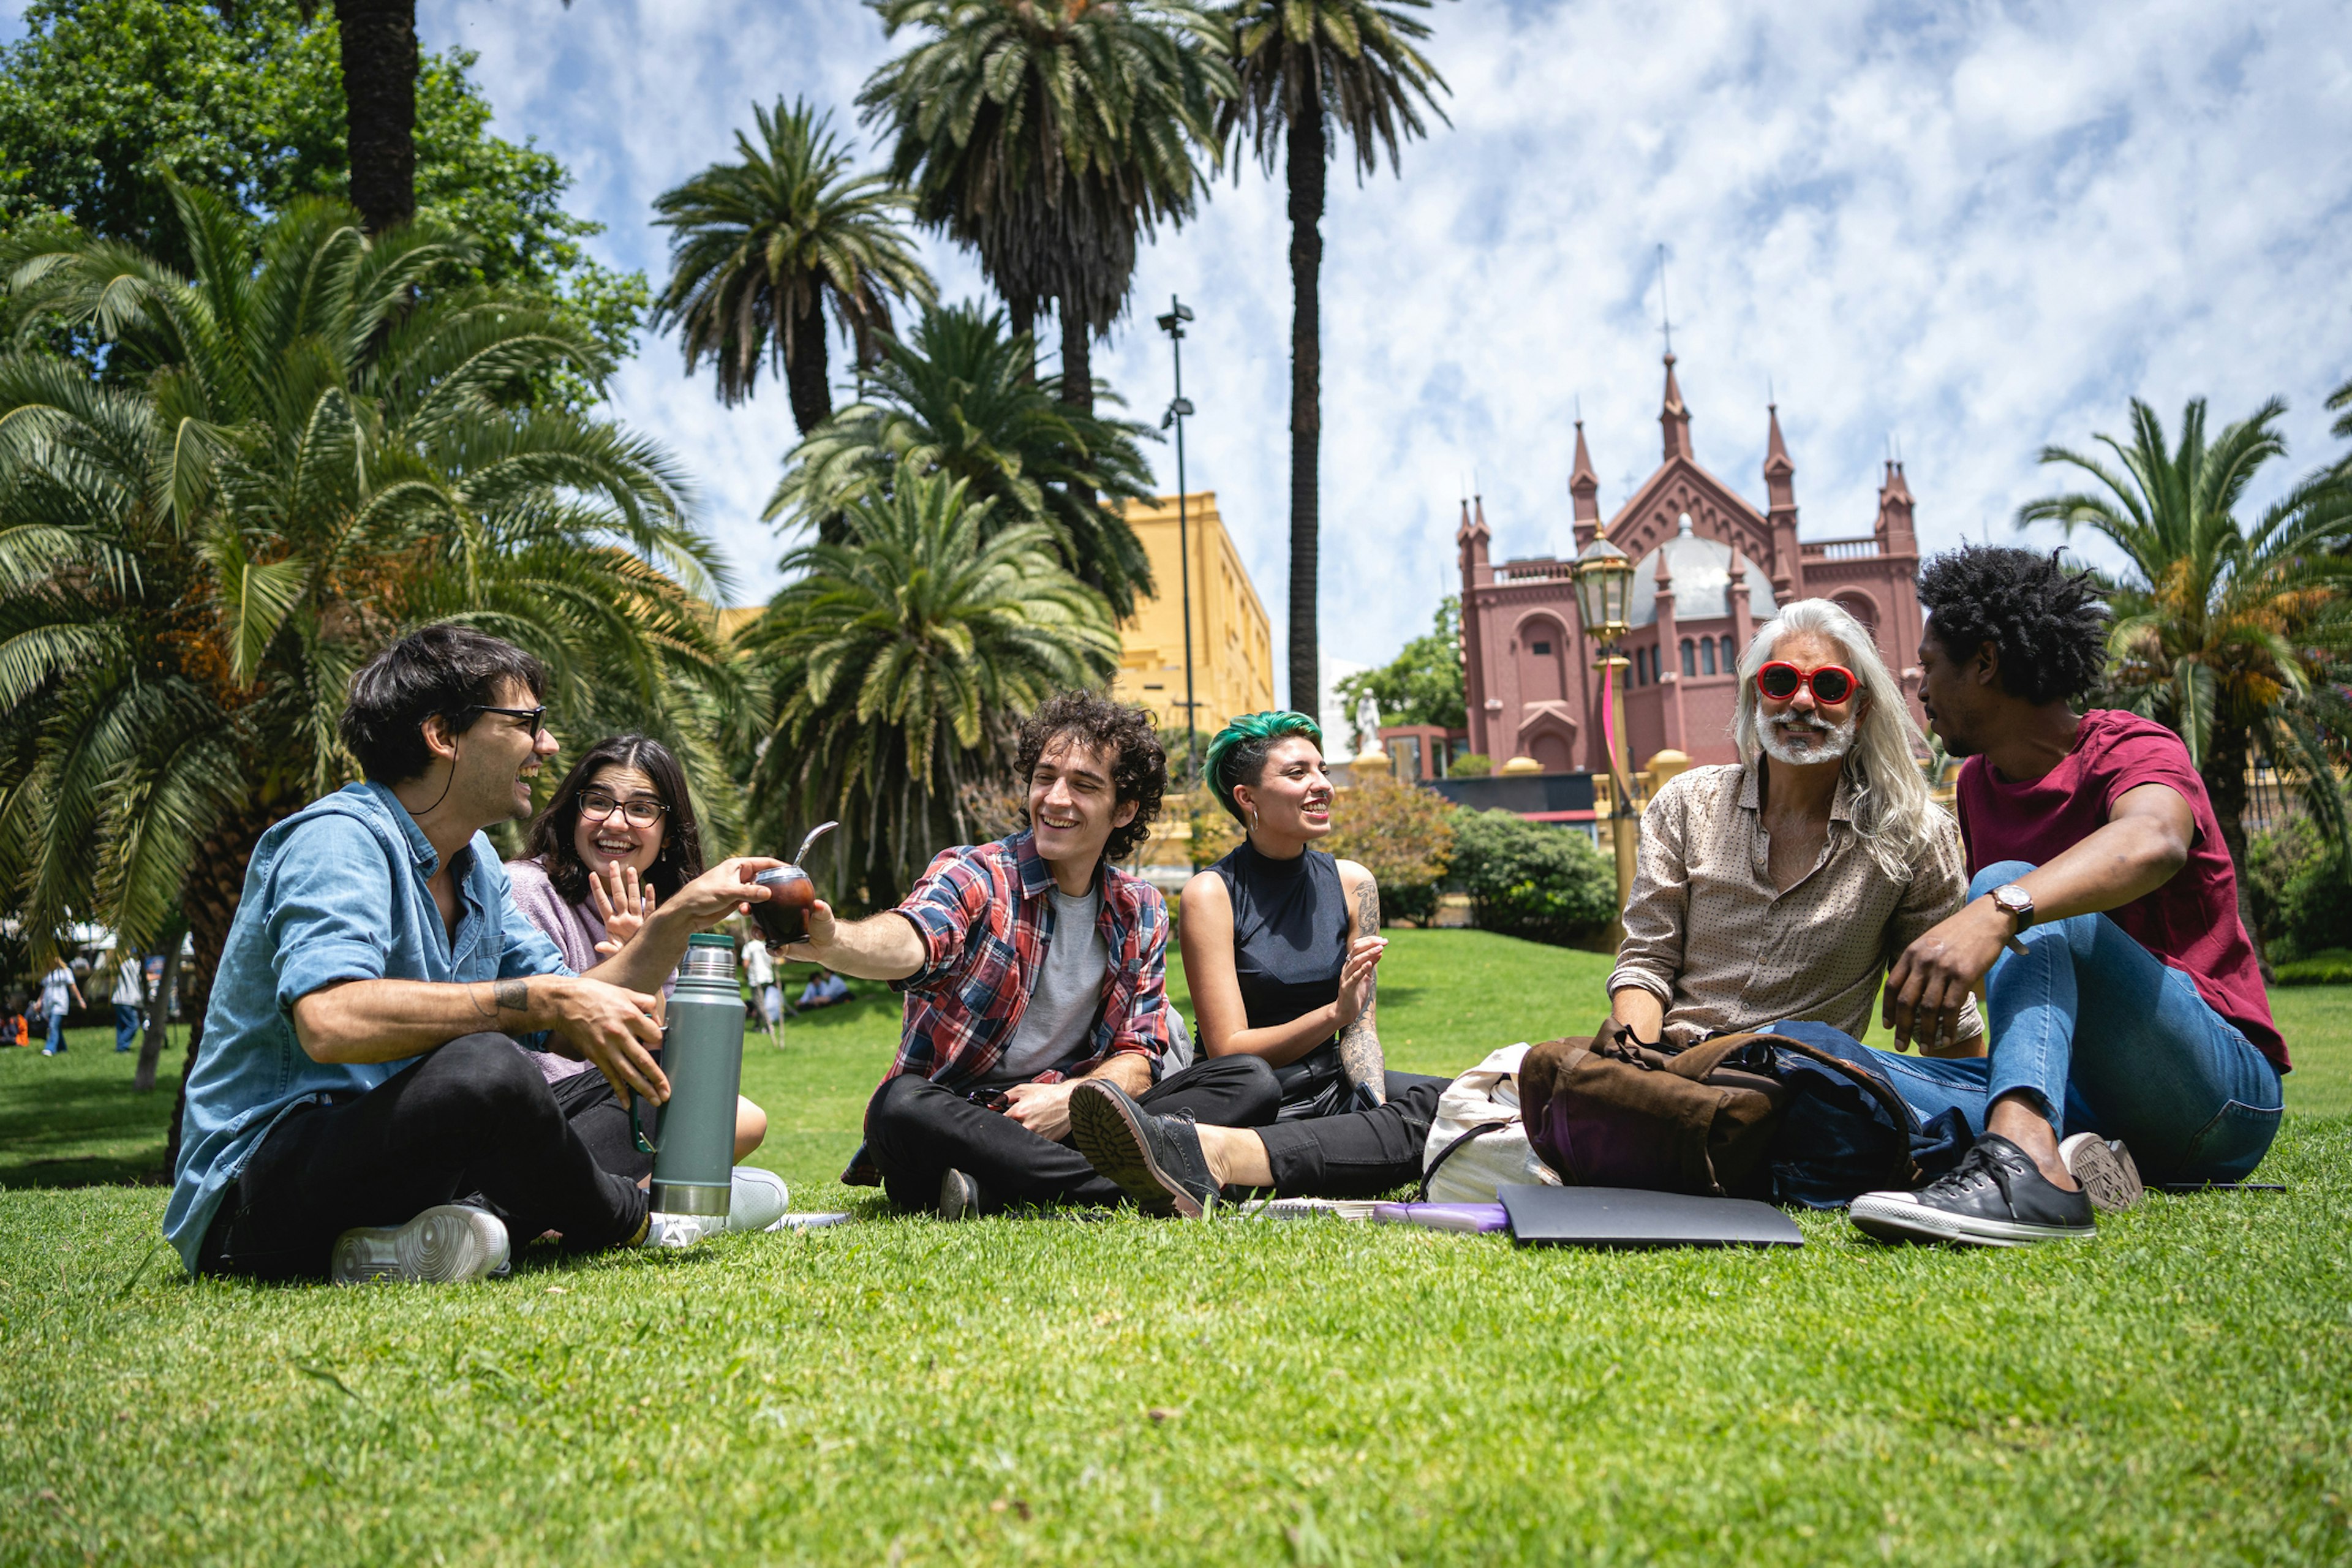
[506,736,786,1229]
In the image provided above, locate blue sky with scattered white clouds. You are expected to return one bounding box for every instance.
[13,0,2352,700]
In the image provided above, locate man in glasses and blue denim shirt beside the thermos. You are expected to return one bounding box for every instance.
[165,625,776,1281]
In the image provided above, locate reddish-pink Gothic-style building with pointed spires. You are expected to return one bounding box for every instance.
[1456,355,1921,774]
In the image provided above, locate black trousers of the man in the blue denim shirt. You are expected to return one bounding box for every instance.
[198,1035,644,1279]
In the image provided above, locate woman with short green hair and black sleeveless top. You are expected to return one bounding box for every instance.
[1070,712,1447,1215]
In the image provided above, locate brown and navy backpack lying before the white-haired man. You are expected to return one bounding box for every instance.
[1520,1023,1964,1208]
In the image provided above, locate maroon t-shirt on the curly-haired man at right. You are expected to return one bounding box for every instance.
[1957,707,2288,1072]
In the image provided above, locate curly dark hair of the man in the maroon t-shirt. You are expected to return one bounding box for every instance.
[1919,545,2108,703]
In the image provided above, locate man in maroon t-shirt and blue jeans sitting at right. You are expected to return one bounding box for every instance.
[1853,545,2288,1246]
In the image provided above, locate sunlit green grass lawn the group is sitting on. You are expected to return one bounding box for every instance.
[0,931,2352,1563]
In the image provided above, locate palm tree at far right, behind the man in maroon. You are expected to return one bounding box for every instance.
[2018,398,2352,949]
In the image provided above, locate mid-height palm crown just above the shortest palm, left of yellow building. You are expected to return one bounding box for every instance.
[764,306,1153,620]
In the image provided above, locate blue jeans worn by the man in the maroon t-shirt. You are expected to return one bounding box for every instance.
[1872,861,2284,1183]
